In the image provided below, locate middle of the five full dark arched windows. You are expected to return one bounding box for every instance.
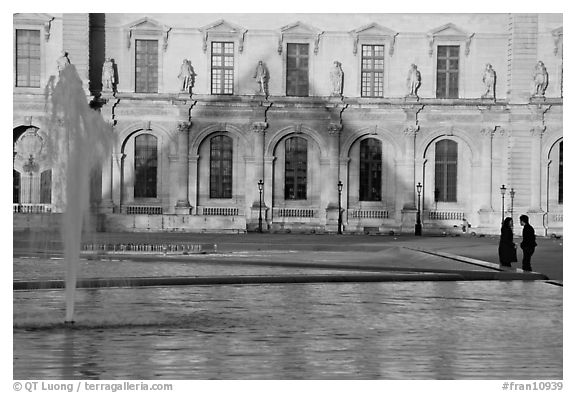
[284,137,308,200]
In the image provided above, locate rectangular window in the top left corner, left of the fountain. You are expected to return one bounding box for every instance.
[16,30,40,87]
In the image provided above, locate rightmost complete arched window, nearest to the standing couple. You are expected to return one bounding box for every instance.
[434,139,458,202]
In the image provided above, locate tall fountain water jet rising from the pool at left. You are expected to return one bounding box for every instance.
[49,64,114,326]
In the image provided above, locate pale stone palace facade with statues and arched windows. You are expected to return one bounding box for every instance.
[13,14,563,235]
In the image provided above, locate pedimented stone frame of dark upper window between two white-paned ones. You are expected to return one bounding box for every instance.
[278,22,324,97]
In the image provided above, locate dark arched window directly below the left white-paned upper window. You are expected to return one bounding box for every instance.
[210,135,232,198]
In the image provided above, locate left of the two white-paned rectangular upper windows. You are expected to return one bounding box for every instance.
[211,42,234,94]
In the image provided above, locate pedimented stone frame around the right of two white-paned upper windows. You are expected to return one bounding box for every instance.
[349,23,398,99]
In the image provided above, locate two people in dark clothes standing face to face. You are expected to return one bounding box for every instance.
[498,214,537,272]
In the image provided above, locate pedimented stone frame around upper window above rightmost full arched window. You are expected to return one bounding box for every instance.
[426,23,475,99]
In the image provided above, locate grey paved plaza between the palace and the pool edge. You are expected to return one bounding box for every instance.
[14,232,563,282]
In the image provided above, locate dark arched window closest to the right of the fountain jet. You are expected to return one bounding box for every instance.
[134,134,158,198]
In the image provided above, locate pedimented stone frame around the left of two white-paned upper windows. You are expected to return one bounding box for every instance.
[198,19,248,95]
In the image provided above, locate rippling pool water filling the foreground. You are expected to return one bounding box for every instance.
[14,281,562,379]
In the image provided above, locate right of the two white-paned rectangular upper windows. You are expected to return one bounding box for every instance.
[362,45,384,97]
